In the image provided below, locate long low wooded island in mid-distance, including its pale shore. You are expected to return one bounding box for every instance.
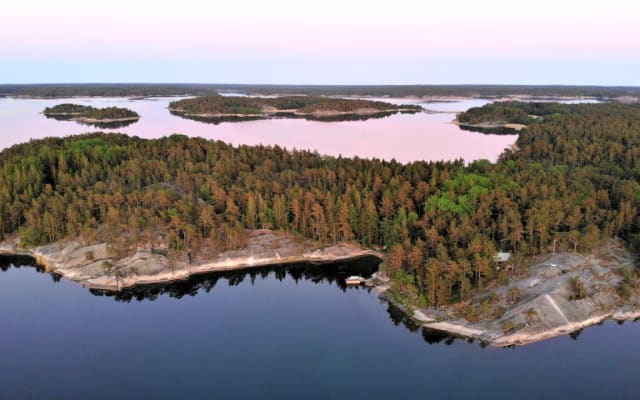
[169,95,422,122]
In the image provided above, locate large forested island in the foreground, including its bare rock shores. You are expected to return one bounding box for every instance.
[0,102,640,345]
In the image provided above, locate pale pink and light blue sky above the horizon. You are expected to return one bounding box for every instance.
[0,0,640,86]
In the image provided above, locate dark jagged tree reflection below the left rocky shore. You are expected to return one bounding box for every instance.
[91,257,380,302]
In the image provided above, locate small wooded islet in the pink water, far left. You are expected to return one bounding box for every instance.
[42,103,140,128]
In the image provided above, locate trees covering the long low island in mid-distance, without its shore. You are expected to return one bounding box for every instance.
[169,95,422,115]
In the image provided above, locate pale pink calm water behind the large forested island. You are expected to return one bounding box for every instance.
[0,98,517,162]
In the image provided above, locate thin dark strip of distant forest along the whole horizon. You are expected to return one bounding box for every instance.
[0,83,640,99]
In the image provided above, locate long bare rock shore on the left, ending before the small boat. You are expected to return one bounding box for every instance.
[0,230,382,291]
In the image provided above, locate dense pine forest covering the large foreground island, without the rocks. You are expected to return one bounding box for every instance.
[0,103,640,306]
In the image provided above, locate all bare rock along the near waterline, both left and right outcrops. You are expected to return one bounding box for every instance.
[0,230,640,347]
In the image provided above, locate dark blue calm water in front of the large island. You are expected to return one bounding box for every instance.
[0,259,640,399]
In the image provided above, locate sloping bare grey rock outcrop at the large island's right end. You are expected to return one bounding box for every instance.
[413,245,640,347]
